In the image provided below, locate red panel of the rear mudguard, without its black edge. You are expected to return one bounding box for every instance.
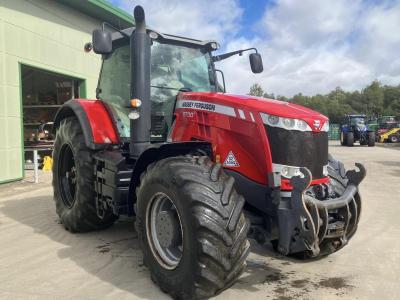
[74,99,119,144]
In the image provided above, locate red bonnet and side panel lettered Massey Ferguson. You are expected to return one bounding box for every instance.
[172,92,328,190]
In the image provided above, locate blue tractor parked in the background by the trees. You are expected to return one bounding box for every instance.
[340,115,375,147]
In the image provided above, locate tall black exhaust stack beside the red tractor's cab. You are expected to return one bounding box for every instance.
[129,5,151,159]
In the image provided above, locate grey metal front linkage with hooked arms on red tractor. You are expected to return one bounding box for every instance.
[278,163,366,257]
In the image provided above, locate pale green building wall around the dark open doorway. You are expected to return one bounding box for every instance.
[0,0,101,183]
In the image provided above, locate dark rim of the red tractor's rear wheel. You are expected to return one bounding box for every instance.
[58,144,77,208]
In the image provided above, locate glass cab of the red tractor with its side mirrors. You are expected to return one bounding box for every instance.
[93,28,262,142]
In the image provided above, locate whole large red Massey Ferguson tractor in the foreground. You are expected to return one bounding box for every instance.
[53,6,365,299]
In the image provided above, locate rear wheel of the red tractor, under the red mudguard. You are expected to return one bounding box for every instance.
[53,117,117,232]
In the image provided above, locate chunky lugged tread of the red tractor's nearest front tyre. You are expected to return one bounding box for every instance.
[137,155,249,299]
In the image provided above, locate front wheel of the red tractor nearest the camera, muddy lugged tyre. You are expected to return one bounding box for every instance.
[136,155,249,299]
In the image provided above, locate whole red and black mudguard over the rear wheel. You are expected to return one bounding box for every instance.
[53,99,120,150]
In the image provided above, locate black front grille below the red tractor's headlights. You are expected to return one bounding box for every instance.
[265,125,328,179]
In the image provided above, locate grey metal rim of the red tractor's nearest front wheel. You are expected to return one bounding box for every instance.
[146,192,183,270]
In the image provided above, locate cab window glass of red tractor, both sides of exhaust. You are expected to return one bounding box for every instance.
[98,41,215,141]
